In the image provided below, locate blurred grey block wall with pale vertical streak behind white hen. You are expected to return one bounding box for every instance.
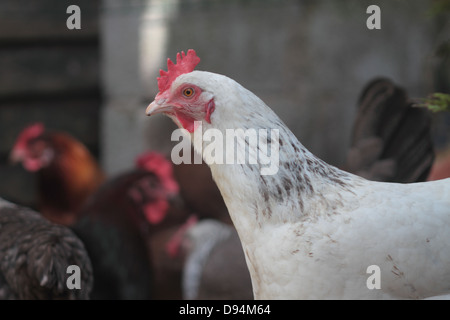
[102,0,450,172]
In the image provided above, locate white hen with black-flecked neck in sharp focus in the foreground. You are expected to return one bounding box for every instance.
[147,50,450,299]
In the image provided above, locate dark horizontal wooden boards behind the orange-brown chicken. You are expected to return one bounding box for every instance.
[0,0,101,205]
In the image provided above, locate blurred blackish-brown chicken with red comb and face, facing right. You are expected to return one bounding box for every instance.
[73,153,188,299]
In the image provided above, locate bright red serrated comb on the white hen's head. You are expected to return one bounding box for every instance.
[158,49,200,94]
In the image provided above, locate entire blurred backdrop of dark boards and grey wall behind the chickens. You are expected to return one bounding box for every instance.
[0,0,450,206]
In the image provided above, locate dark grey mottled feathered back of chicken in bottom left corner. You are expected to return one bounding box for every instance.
[0,198,93,300]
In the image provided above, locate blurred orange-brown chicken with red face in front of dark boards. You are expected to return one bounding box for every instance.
[10,123,104,225]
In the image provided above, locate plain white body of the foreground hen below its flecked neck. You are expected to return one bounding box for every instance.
[234,179,450,299]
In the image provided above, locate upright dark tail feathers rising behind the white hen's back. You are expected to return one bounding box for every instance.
[343,78,435,183]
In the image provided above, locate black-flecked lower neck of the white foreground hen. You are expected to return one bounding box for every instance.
[194,103,357,228]
